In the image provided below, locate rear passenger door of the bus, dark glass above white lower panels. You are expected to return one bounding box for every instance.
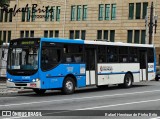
[139,50,148,81]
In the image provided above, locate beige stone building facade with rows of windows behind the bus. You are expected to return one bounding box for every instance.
[0,0,160,64]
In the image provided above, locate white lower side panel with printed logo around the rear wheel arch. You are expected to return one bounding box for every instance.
[97,63,140,85]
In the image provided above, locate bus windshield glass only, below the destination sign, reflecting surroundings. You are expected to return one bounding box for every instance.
[8,47,38,70]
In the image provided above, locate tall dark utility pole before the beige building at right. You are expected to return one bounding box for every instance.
[149,2,153,44]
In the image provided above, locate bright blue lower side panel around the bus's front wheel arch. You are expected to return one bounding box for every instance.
[39,64,86,89]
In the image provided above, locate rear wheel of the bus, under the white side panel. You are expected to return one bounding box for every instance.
[123,73,133,88]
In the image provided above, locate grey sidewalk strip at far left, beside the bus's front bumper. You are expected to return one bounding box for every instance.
[0,80,33,96]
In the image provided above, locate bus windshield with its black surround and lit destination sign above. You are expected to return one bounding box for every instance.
[7,40,39,74]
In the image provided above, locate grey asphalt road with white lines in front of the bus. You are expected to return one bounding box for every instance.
[0,81,160,119]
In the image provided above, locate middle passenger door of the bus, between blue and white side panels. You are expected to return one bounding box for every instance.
[85,48,96,85]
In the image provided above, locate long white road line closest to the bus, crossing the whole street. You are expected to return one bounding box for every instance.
[0,90,160,107]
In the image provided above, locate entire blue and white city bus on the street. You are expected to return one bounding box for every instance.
[7,38,156,94]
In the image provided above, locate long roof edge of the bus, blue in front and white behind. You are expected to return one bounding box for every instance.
[10,38,154,47]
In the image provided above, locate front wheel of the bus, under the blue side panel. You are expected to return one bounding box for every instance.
[62,77,75,95]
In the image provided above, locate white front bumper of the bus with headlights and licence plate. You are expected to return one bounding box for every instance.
[7,81,41,89]
